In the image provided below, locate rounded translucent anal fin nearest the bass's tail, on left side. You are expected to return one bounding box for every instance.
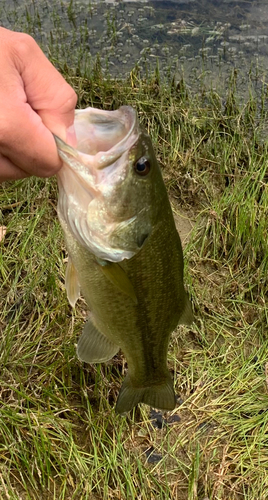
[76,319,119,363]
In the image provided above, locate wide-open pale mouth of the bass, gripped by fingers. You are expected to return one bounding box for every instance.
[53,106,141,191]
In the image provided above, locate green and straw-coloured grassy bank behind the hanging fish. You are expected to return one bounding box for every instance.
[0,71,268,500]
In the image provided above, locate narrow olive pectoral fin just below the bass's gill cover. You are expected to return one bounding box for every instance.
[97,259,138,304]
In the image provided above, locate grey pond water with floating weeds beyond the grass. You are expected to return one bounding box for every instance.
[0,0,268,96]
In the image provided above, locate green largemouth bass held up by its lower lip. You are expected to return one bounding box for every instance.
[55,106,193,414]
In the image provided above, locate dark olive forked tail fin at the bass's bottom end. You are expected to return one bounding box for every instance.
[115,374,176,414]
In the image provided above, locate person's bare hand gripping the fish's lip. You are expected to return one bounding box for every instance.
[0,28,77,182]
